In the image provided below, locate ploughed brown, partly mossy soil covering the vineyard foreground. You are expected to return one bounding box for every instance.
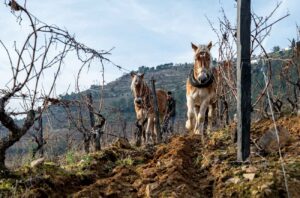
[0,117,300,197]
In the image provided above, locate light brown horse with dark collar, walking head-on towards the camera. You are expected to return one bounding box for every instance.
[186,42,217,140]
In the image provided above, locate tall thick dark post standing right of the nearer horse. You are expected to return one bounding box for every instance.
[237,0,251,162]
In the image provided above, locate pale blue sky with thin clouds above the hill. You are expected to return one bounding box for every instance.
[0,0,300,94]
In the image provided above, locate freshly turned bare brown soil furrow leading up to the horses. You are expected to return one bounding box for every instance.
[74,136,214,197]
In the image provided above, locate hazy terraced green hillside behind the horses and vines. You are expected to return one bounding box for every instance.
[47,50,291,128]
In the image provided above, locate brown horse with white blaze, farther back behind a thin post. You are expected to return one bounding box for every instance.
[131,72,167,143]
